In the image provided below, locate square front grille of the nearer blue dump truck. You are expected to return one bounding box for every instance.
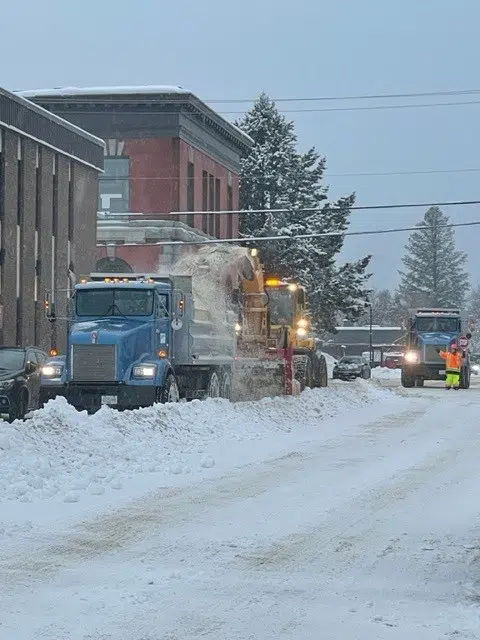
[72,344,116,382]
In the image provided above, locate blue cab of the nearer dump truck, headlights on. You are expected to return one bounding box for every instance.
[40,277,184,412]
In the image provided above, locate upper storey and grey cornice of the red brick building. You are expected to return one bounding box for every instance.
[16,87,253,251]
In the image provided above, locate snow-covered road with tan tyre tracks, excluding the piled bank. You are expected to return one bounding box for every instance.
[0,383,480,640]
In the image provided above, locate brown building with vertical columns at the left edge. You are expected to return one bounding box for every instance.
[0,89,104,349]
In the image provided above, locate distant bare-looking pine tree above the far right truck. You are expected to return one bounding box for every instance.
[399,207,469,308]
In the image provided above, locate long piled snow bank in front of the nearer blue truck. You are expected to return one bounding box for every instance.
[0,381,396,510]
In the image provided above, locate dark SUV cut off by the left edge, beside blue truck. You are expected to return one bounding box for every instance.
[0,347,47,422]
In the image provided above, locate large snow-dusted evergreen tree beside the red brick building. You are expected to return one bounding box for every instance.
[236,93,371,330]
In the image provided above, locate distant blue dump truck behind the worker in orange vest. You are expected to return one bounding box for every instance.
[402,309,471,389]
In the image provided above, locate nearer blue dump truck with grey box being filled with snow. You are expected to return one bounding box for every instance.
[40,274,236,413]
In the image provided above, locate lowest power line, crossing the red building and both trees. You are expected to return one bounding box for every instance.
[98,220,480,247]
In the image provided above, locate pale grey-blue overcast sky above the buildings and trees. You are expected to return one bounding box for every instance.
[0,0,480,287]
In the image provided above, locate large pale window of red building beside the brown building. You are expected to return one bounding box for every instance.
[98,156,130,213]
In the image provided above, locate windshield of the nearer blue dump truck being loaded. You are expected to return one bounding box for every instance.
[75,288,157,317]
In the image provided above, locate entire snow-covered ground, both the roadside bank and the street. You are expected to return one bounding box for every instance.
[0,381,480,640]
